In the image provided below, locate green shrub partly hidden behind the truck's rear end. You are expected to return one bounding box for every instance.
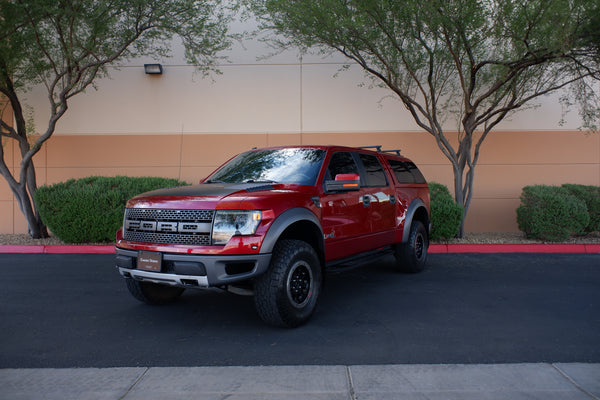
[429,182,463,240]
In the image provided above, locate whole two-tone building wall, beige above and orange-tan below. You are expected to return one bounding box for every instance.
[0,33,600,233]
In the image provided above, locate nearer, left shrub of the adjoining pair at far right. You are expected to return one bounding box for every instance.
[517,185,590,242]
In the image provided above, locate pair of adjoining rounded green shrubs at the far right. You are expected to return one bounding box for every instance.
[517,184,600,242]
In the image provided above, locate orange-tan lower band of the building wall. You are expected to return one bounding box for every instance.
[0,131,600,233]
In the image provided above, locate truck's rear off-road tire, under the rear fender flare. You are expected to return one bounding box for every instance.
[394,221,429,274]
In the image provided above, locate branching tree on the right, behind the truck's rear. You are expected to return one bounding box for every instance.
[246,0,600,235]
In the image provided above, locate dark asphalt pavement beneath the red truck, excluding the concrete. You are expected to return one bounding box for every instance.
[0,254,600,368]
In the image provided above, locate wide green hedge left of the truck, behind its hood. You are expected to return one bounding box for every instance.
[35,176,185,243]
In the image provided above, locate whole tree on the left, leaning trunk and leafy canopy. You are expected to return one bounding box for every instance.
[0,0,230,238]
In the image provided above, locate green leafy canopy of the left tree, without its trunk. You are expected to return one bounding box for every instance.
[0,0,230,89]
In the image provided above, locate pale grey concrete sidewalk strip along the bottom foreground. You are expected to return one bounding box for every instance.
[0,363,600,400]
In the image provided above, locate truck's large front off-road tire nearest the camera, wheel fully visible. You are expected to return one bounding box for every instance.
[254,240,323,328]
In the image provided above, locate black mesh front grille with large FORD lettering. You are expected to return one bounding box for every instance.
[123,208,214,246]
